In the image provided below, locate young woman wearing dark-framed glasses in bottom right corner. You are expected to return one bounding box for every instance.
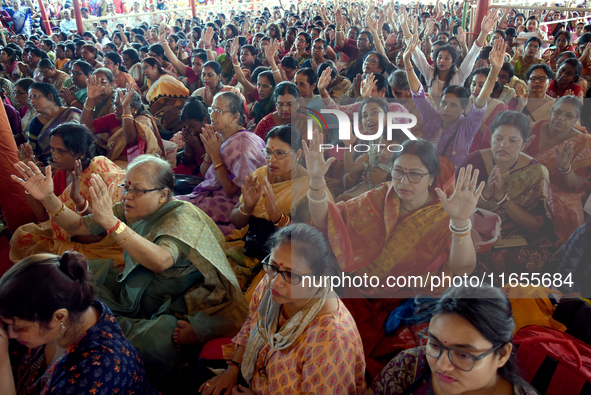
[370,286,537,395]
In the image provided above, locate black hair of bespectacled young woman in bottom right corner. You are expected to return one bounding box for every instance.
[431,286,535,392]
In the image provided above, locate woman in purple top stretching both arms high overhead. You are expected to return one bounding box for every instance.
[404,35,505,166]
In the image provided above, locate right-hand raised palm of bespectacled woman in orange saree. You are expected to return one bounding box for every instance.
[435,165,485,224]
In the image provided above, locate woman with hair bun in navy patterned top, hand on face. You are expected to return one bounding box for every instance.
[0,252,157,395]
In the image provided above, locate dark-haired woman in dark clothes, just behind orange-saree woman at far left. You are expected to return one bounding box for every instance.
[29,82,80,165]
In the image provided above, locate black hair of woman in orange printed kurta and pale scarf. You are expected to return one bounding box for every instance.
[268,223,343,294]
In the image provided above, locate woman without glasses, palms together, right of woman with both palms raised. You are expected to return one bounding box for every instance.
[462,111,558,274]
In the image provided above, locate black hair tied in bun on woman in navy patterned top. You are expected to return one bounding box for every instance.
[0,251,94,329]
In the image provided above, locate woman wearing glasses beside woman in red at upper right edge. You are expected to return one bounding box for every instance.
[507,63,555,122]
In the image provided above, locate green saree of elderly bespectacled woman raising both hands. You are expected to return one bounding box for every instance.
[83,200,248,380]
